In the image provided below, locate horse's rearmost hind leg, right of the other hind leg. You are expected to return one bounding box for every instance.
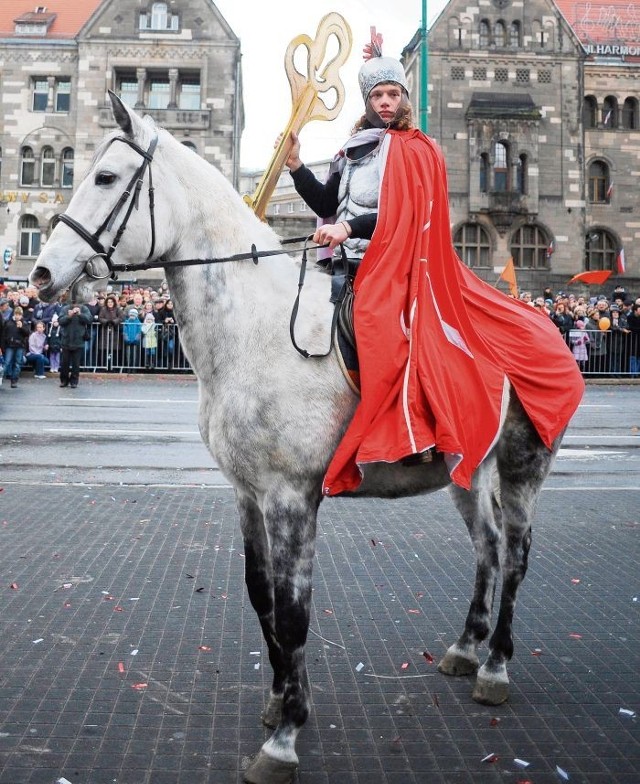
[472,399,560,705]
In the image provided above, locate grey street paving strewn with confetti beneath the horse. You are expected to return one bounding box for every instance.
[0,381,640,784]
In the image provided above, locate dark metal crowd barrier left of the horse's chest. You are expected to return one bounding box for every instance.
[81,324,192,373]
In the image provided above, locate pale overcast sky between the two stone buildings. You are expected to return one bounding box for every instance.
[214,0,447,169]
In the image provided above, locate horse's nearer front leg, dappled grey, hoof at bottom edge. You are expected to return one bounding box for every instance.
[244,489,321,784]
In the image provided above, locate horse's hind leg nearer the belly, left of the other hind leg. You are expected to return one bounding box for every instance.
[438,456,500,676]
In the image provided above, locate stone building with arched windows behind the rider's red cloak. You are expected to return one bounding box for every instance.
[403,0,640,293]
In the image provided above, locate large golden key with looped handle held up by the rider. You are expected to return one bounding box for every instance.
[244,11,351,218]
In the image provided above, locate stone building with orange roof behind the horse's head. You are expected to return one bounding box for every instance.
[0,0,244,278]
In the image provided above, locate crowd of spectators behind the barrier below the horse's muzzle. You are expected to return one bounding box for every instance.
[0,282,178,388]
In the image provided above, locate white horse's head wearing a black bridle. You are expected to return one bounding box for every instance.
[29,92,169,302]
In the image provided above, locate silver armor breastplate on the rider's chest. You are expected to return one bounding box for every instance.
[336,146,381,259]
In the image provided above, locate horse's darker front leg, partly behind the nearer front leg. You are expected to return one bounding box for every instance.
[236,493,285,729]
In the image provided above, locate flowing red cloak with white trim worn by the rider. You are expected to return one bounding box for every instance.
[324,130,584,495]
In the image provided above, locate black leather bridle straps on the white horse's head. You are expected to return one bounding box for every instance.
[58,134,158,280]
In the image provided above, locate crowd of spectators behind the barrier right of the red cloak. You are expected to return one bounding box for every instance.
[520,286,640,378]
